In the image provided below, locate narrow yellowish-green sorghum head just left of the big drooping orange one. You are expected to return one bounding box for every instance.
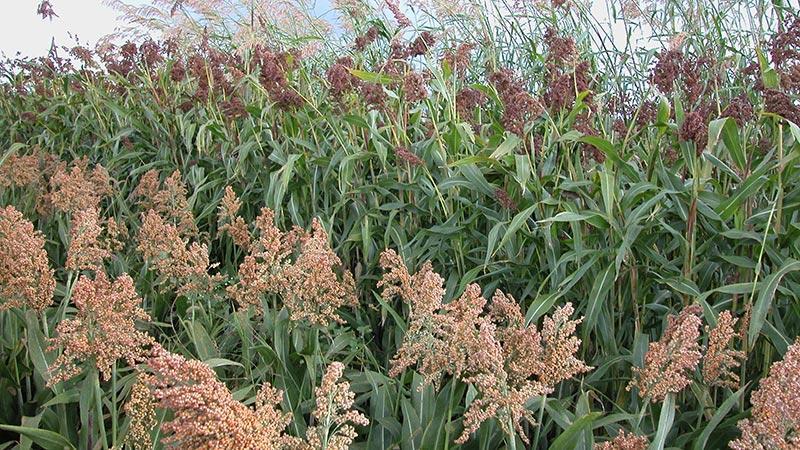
[125,373,158,450]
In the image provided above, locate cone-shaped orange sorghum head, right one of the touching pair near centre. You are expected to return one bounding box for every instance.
[280,218,358,327]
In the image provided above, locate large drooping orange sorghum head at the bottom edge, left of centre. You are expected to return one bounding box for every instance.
[147,346,300,449]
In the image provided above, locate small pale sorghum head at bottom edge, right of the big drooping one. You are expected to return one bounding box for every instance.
[301,362,369,450]
